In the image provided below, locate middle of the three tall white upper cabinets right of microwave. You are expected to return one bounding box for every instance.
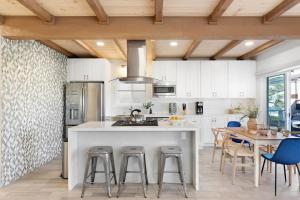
[200,61,228,98]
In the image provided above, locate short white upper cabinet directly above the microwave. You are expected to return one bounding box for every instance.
[152,61,177,84]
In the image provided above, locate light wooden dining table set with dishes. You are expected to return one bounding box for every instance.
[225,127,291,187]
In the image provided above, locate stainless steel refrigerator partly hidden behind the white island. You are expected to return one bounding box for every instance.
[62,81,105,178]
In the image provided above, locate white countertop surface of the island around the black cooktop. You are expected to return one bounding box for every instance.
[69,120,198,132]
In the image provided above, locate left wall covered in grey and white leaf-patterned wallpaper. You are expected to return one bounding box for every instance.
[0,37,67,186]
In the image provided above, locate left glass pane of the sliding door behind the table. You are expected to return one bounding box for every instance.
[267,74,286,128]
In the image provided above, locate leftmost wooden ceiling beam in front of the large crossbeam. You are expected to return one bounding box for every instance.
[18,0,55,24]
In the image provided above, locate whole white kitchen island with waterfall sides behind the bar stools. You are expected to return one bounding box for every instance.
[68,121,200,190]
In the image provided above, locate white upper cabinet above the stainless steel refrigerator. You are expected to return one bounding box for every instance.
[68,58,111,81]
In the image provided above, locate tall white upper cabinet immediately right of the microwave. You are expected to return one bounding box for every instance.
[176,61,200,98]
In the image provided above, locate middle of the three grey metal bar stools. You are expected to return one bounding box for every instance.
[117,146,148,198]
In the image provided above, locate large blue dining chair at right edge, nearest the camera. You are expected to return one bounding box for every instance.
[261,138,300,196]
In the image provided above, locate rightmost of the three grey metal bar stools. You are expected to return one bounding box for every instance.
[157,146,187,198]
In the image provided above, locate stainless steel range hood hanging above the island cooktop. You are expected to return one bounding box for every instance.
[117,40,156,84]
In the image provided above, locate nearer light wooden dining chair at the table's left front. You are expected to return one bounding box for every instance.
[221,133,254,184]
